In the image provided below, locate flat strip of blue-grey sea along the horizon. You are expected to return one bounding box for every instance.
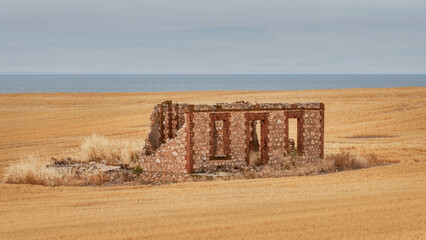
[0,74,426,93]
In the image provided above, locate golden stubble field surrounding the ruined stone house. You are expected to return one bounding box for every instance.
[0,88,426,239]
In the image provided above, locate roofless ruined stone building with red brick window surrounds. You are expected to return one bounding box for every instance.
[141,101,324,174]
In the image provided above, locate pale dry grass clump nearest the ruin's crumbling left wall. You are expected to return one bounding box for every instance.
[75,134,142,165]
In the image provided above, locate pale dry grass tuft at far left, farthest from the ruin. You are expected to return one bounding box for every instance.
[3,156,72,186]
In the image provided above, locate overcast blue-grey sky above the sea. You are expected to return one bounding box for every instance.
[0,0,426,74]
